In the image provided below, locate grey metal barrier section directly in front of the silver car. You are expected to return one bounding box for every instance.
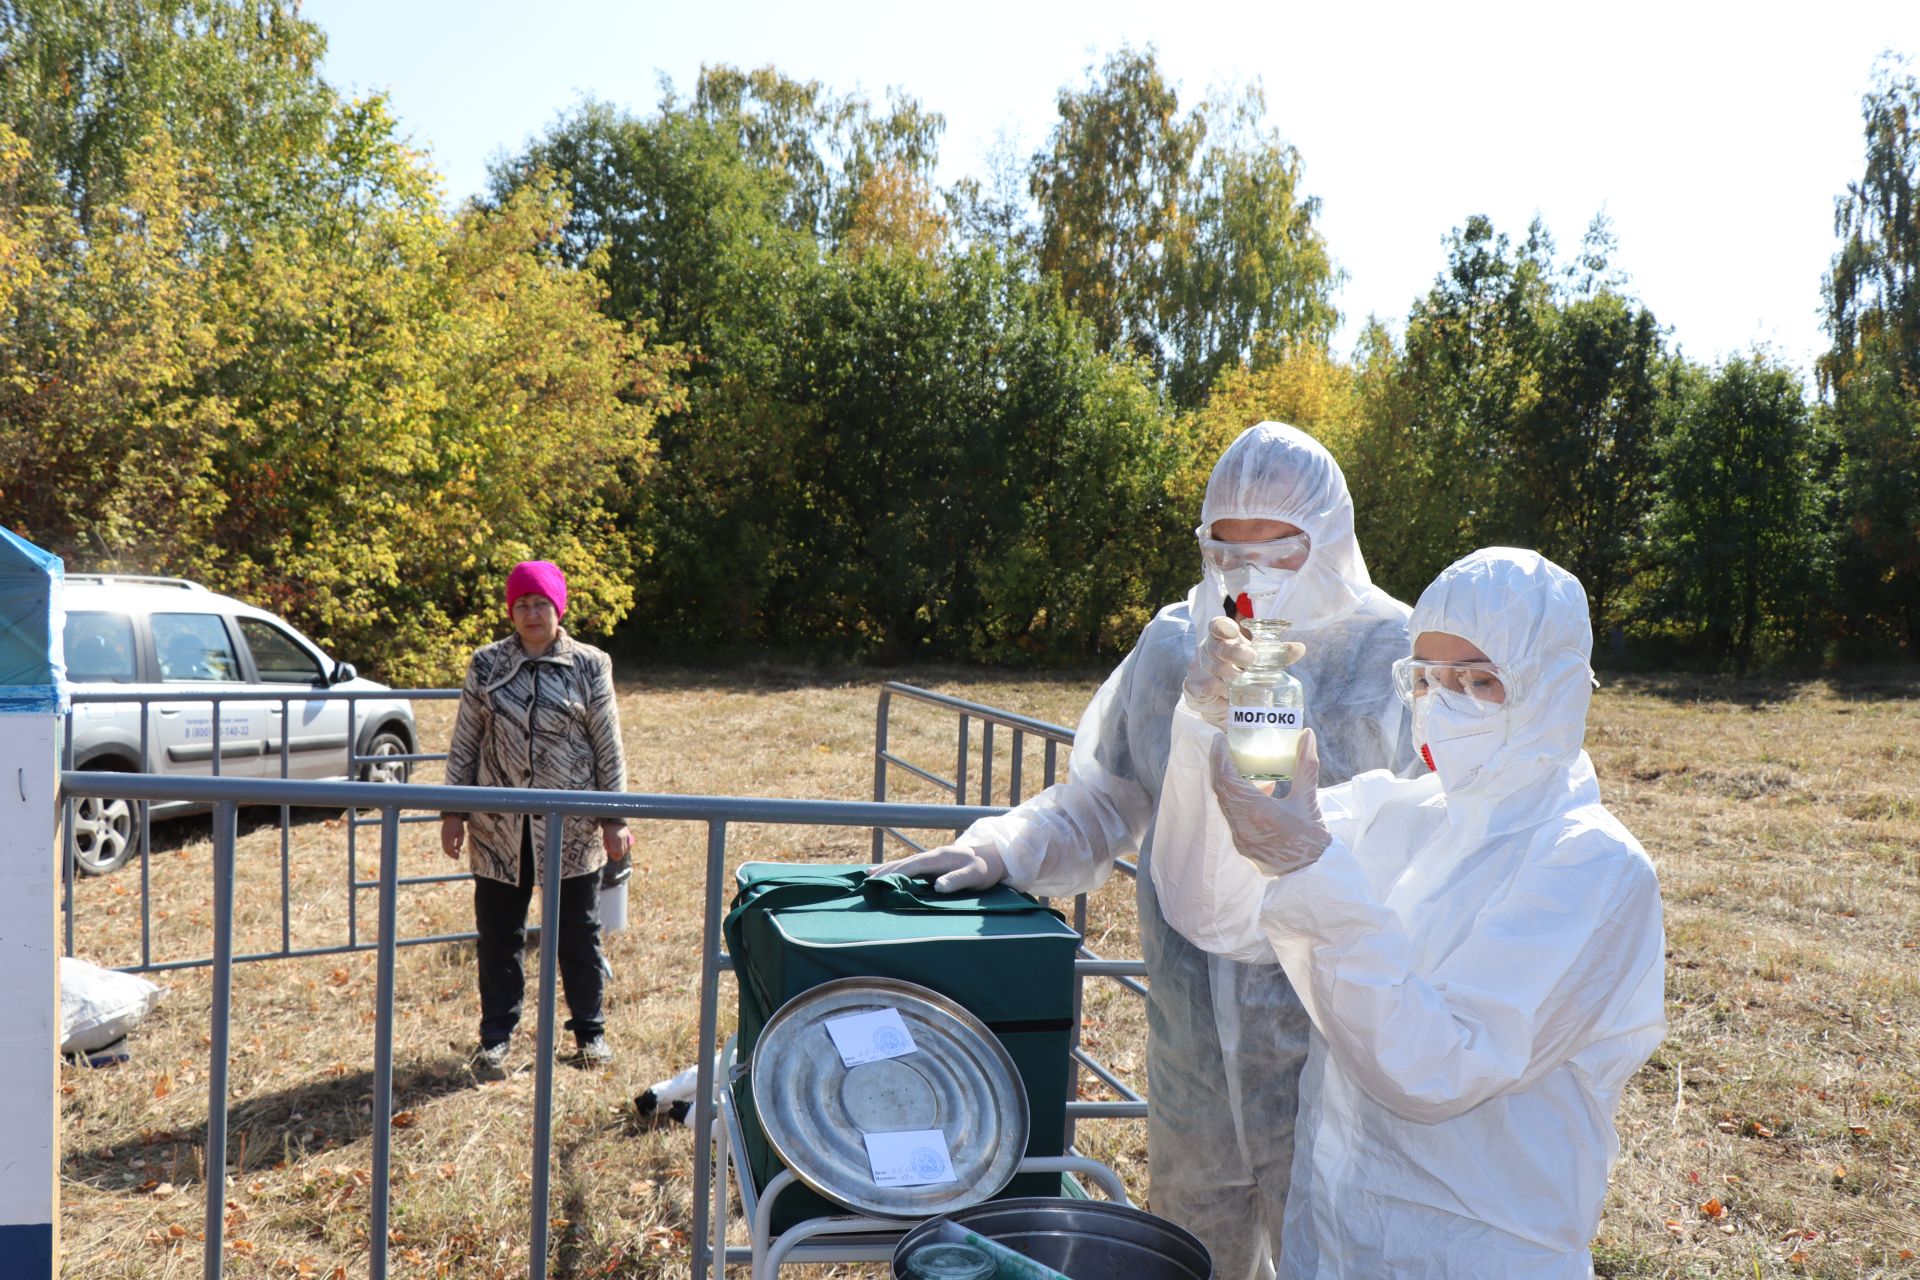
[60,685,456,973]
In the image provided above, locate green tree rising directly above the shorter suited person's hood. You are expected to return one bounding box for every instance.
[1369,217,1663,626]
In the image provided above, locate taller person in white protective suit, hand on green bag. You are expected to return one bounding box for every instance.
[883,422,1413,1280]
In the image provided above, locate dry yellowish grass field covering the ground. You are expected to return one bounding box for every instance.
[61,670,1920,1280]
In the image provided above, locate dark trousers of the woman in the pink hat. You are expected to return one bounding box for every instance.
[474,821,607,1044]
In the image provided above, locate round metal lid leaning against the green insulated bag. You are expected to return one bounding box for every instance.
[753,977,1029,1219]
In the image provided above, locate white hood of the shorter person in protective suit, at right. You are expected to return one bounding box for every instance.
[1407,547,1594,831]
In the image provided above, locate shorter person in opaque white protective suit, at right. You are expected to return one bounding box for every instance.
[1154,547,1667,1280]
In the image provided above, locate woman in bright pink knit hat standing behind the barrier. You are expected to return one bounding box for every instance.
[440,560,634,1071]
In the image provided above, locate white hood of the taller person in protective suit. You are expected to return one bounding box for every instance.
[1192,422,1373,631]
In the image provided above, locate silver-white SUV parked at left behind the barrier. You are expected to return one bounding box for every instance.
[63,574,419,875]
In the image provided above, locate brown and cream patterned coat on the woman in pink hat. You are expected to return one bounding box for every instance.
[447,628,626,885]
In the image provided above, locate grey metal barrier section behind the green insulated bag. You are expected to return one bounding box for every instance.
[874,679,1146,1151]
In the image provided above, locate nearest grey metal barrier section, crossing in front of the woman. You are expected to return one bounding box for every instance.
[61,770,998,1280]
